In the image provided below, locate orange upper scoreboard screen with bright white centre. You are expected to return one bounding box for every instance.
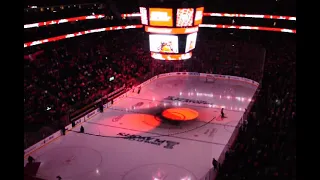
[149,8,173,27]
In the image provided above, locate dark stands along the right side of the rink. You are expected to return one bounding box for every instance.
[218,32,296,180]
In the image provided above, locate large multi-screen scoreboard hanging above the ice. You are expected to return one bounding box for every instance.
[140,7,204,60]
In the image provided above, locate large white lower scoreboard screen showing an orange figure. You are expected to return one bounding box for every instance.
[149,34,179,53]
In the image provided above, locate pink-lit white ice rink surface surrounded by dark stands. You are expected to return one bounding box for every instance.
[25,76,257,180]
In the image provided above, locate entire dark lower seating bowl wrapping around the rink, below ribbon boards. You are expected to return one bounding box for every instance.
[24,15,296,180]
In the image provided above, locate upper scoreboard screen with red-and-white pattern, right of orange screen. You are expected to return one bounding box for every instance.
[176,8,194,27]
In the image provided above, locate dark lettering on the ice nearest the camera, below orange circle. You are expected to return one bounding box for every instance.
[117,133,180,149]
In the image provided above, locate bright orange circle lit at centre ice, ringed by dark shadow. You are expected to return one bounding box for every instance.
[161,108,199,121]
